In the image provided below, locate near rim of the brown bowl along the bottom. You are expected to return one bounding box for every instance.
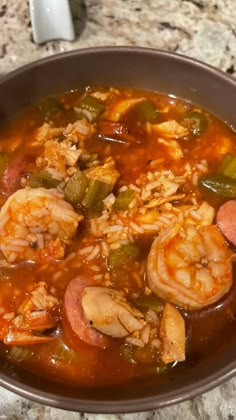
[0,361,236,414]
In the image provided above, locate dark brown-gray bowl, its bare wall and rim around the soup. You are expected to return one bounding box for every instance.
[0,47,236,413]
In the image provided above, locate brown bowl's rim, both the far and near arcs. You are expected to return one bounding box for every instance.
[0,46,236,414]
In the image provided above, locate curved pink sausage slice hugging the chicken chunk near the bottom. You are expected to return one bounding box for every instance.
[64,275,110,348]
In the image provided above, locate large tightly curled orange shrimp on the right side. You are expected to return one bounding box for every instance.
[147,223,232,310]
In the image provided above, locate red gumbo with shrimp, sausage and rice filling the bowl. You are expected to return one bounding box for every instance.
[0,87,236,387]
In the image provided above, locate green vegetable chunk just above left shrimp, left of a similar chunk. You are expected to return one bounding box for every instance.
[64,171,89,204]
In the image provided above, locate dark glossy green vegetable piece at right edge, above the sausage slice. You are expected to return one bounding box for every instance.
[199,173,236,198]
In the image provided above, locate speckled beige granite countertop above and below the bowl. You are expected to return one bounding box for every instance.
[0,0,236,420]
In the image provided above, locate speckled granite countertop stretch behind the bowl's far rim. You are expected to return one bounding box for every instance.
[0,0,236,74]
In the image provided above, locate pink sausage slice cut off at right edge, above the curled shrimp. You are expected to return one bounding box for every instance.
[216,200,236,246]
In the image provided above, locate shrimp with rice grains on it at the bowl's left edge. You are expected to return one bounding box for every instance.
[0,188,83,263]
